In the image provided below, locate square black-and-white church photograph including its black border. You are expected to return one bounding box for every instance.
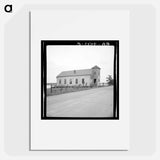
[41,40,119,120]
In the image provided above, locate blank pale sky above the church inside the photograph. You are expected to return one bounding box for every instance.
[47,45,114,83]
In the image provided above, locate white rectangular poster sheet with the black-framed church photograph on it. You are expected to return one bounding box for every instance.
[30,9,129,151]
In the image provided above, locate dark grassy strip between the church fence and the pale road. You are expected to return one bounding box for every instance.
[47,87,106,96]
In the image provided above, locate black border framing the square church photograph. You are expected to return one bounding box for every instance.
[41,40,119,120]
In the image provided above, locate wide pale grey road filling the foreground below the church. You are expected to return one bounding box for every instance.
[47,86,113,117]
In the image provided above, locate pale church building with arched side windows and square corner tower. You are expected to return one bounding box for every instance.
[56,66,100,86]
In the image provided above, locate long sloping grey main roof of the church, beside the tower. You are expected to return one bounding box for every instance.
[57,69,92,78]
